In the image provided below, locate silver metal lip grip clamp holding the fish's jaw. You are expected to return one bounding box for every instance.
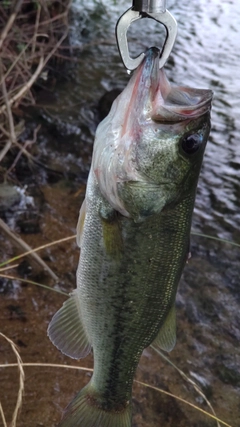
[116,0,177,71]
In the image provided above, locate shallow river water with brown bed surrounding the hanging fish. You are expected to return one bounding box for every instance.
[0,0,240,427]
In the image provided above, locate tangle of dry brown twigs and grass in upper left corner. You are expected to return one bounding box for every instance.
[0,0,71,179]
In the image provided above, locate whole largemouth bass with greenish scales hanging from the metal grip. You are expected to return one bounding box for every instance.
[48,48,212,427]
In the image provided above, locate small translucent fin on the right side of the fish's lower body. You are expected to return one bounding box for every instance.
[151,305,176,352]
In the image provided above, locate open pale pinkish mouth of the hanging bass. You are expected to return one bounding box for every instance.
[133,47,213,123]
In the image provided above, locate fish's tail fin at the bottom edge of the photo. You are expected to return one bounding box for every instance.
[58,385,132,427]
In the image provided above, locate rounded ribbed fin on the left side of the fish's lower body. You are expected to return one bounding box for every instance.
[48,290,91,359]
